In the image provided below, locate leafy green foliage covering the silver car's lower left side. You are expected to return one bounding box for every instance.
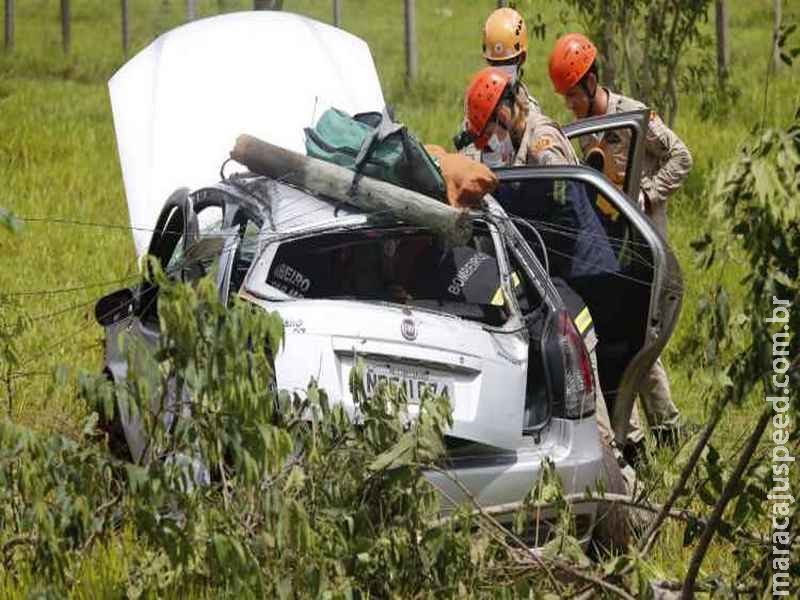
[0,275,600,597]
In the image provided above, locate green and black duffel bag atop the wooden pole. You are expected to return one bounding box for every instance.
[305,108,447,201]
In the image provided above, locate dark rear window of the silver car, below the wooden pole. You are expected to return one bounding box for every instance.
[266,223,508,325]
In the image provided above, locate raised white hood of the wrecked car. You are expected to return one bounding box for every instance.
[109,11,384,256]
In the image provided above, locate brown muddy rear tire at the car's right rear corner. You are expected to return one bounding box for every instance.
[592,442,632,554]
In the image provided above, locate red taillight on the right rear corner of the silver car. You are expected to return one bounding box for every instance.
[545,311,595,419]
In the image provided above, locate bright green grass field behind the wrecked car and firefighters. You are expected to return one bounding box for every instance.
[0,0,800,597]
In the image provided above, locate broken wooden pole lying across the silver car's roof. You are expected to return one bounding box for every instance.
[231,134,472,245]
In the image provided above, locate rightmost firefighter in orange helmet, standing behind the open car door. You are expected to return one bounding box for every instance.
[549,33,692,446]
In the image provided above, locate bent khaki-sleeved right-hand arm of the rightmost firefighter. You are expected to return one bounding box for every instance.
[641,113,692,204]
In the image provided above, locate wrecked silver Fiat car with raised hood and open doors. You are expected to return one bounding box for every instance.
[96,13,680,540]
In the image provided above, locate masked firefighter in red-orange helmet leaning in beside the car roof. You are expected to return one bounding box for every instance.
[464,67,619,452]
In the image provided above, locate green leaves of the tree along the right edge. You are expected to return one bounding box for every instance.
[683,103,800,589]
